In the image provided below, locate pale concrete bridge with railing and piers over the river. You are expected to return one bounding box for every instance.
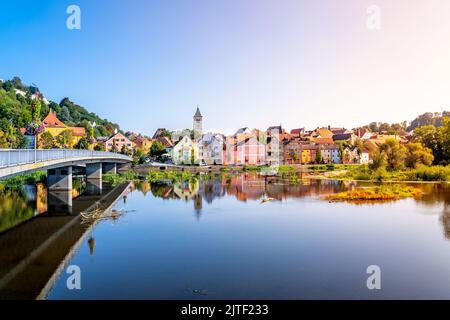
[0,149,132,191]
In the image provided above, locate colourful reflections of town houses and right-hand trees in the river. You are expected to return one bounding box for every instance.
[134,173,450,239]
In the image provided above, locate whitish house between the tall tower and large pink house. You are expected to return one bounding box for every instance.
[198,133,225,165]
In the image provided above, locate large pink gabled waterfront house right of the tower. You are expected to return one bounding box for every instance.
[235,135,266,165]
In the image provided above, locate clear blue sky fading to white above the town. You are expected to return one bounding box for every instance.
[0,0,450,134]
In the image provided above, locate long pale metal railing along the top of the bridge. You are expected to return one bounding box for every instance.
[0,149,132,168]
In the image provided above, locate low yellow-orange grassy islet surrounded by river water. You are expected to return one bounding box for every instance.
[325,185,422,201]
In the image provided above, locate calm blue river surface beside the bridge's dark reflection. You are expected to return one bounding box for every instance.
[0,174,450,299]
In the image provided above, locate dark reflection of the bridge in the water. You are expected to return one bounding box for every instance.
[0,183,130,300]
